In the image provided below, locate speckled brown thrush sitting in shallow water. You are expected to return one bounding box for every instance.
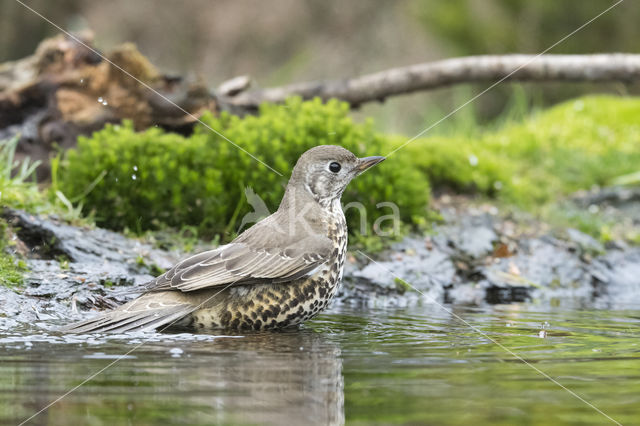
[60,145,385,334]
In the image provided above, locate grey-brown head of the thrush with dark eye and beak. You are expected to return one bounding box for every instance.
[289,145,385,205]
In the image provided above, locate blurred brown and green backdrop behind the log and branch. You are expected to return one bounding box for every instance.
[0,0,640,135]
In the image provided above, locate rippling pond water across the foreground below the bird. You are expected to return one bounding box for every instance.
[0,305,640,425]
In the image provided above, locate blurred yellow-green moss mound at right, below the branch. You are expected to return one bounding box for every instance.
[394,96,640,208]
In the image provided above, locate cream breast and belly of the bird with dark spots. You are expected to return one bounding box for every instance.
[190,207,347,330]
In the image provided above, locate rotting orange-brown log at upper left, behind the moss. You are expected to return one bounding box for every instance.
[0,35,217,178]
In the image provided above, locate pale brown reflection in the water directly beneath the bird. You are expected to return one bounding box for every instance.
[180,330,344,425]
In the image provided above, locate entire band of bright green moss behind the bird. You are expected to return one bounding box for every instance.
[54,96,640,248]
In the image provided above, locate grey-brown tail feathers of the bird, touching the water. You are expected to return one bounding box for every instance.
[59,292,196,334]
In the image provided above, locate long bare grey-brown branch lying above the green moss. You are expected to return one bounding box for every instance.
[221,53,640,110]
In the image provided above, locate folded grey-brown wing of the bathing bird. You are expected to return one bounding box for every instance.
[147,230,333,292]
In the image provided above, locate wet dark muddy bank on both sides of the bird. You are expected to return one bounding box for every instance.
[0,197,640,328]
